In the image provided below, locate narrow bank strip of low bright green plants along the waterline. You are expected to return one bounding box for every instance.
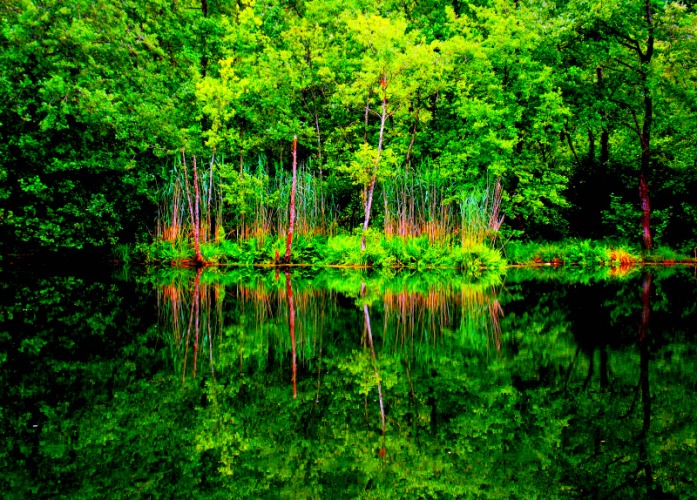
[126,233,697,271]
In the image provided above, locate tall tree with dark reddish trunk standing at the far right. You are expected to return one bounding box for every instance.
[567,0,695,250]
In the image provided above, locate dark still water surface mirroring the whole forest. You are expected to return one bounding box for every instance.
[0,268,697,498]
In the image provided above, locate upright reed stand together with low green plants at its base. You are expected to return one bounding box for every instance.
[153,154,503,269]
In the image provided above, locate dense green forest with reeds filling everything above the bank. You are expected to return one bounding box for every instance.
[0,0,697,255]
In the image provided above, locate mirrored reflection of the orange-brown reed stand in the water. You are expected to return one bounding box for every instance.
[157,269,504,382]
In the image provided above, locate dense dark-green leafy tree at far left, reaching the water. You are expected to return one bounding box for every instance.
[0,0,201,252]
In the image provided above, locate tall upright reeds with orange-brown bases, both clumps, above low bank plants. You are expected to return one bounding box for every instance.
[157,150,503,261]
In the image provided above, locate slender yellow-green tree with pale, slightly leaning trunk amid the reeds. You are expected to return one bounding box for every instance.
[336,15,438,250]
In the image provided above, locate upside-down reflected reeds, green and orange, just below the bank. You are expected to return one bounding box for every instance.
[152,268,503,384]
